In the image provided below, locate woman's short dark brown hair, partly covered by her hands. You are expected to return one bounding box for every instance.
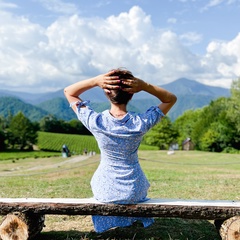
[106,68,134,104]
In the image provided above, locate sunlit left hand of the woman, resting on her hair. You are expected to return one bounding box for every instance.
[96,70,120,92]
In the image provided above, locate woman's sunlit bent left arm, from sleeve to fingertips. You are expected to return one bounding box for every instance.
[64,71,120,112]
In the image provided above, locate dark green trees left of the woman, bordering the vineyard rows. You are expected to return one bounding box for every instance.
[0,111,90,151]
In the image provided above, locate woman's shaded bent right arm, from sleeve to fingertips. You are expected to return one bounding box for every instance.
[123,78,177,114]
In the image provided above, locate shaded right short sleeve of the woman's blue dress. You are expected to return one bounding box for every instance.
[141,106,165,131]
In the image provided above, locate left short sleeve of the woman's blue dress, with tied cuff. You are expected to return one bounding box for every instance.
[70,100,97,131]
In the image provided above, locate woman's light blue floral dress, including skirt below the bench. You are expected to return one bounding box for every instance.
[75,101,164,232]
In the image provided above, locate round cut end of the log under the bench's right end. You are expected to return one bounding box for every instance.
[220,216,240,240]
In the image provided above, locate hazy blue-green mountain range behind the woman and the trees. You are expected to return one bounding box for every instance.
[0,78,230,121]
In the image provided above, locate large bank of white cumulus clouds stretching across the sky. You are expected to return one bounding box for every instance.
[0,6,240,92]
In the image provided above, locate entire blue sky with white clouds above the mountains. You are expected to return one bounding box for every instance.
[0,0,240,92]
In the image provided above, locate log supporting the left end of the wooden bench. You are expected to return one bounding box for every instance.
[0,212,45,240]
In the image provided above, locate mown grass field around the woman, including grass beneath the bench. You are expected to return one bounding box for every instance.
[0,151,240,240]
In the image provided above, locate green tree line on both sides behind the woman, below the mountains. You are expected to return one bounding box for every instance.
[0,78,240,152]
